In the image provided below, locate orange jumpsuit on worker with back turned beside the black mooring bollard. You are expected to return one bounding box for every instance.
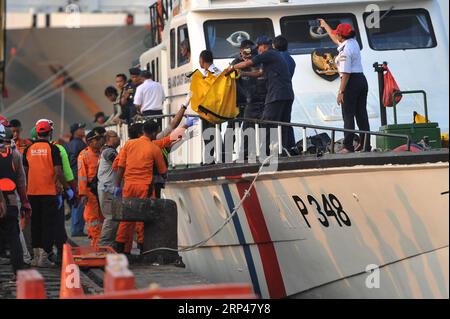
[113,136,172,253]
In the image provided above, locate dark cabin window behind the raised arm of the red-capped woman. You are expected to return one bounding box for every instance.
[280,13,362,54]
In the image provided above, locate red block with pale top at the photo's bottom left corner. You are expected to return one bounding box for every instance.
[16,269,47,299]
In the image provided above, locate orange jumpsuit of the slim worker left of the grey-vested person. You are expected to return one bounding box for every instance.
[78,147,104,246]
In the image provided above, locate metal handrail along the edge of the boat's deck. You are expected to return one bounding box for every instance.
[106,113,411,165]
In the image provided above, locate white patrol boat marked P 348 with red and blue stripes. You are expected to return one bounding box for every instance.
[128,0,449,298]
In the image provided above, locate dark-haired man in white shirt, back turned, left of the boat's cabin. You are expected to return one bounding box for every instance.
[134,70,165,129]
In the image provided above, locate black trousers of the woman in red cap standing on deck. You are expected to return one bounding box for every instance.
[342,73,371,152]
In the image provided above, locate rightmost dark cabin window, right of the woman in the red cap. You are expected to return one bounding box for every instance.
[364,9,437,51]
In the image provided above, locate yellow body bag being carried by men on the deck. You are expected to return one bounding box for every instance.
[191,70,239,124]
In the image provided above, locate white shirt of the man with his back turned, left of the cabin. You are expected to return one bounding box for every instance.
[134,79,165,112]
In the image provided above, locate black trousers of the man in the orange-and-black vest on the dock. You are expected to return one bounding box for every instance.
[28,195,58,253]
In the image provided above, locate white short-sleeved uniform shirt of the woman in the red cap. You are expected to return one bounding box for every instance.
[336,39,364,76]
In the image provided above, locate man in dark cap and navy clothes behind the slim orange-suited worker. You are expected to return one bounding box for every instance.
[66,123,87,237]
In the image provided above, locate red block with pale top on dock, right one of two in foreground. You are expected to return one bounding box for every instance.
[103,254,135,294]
